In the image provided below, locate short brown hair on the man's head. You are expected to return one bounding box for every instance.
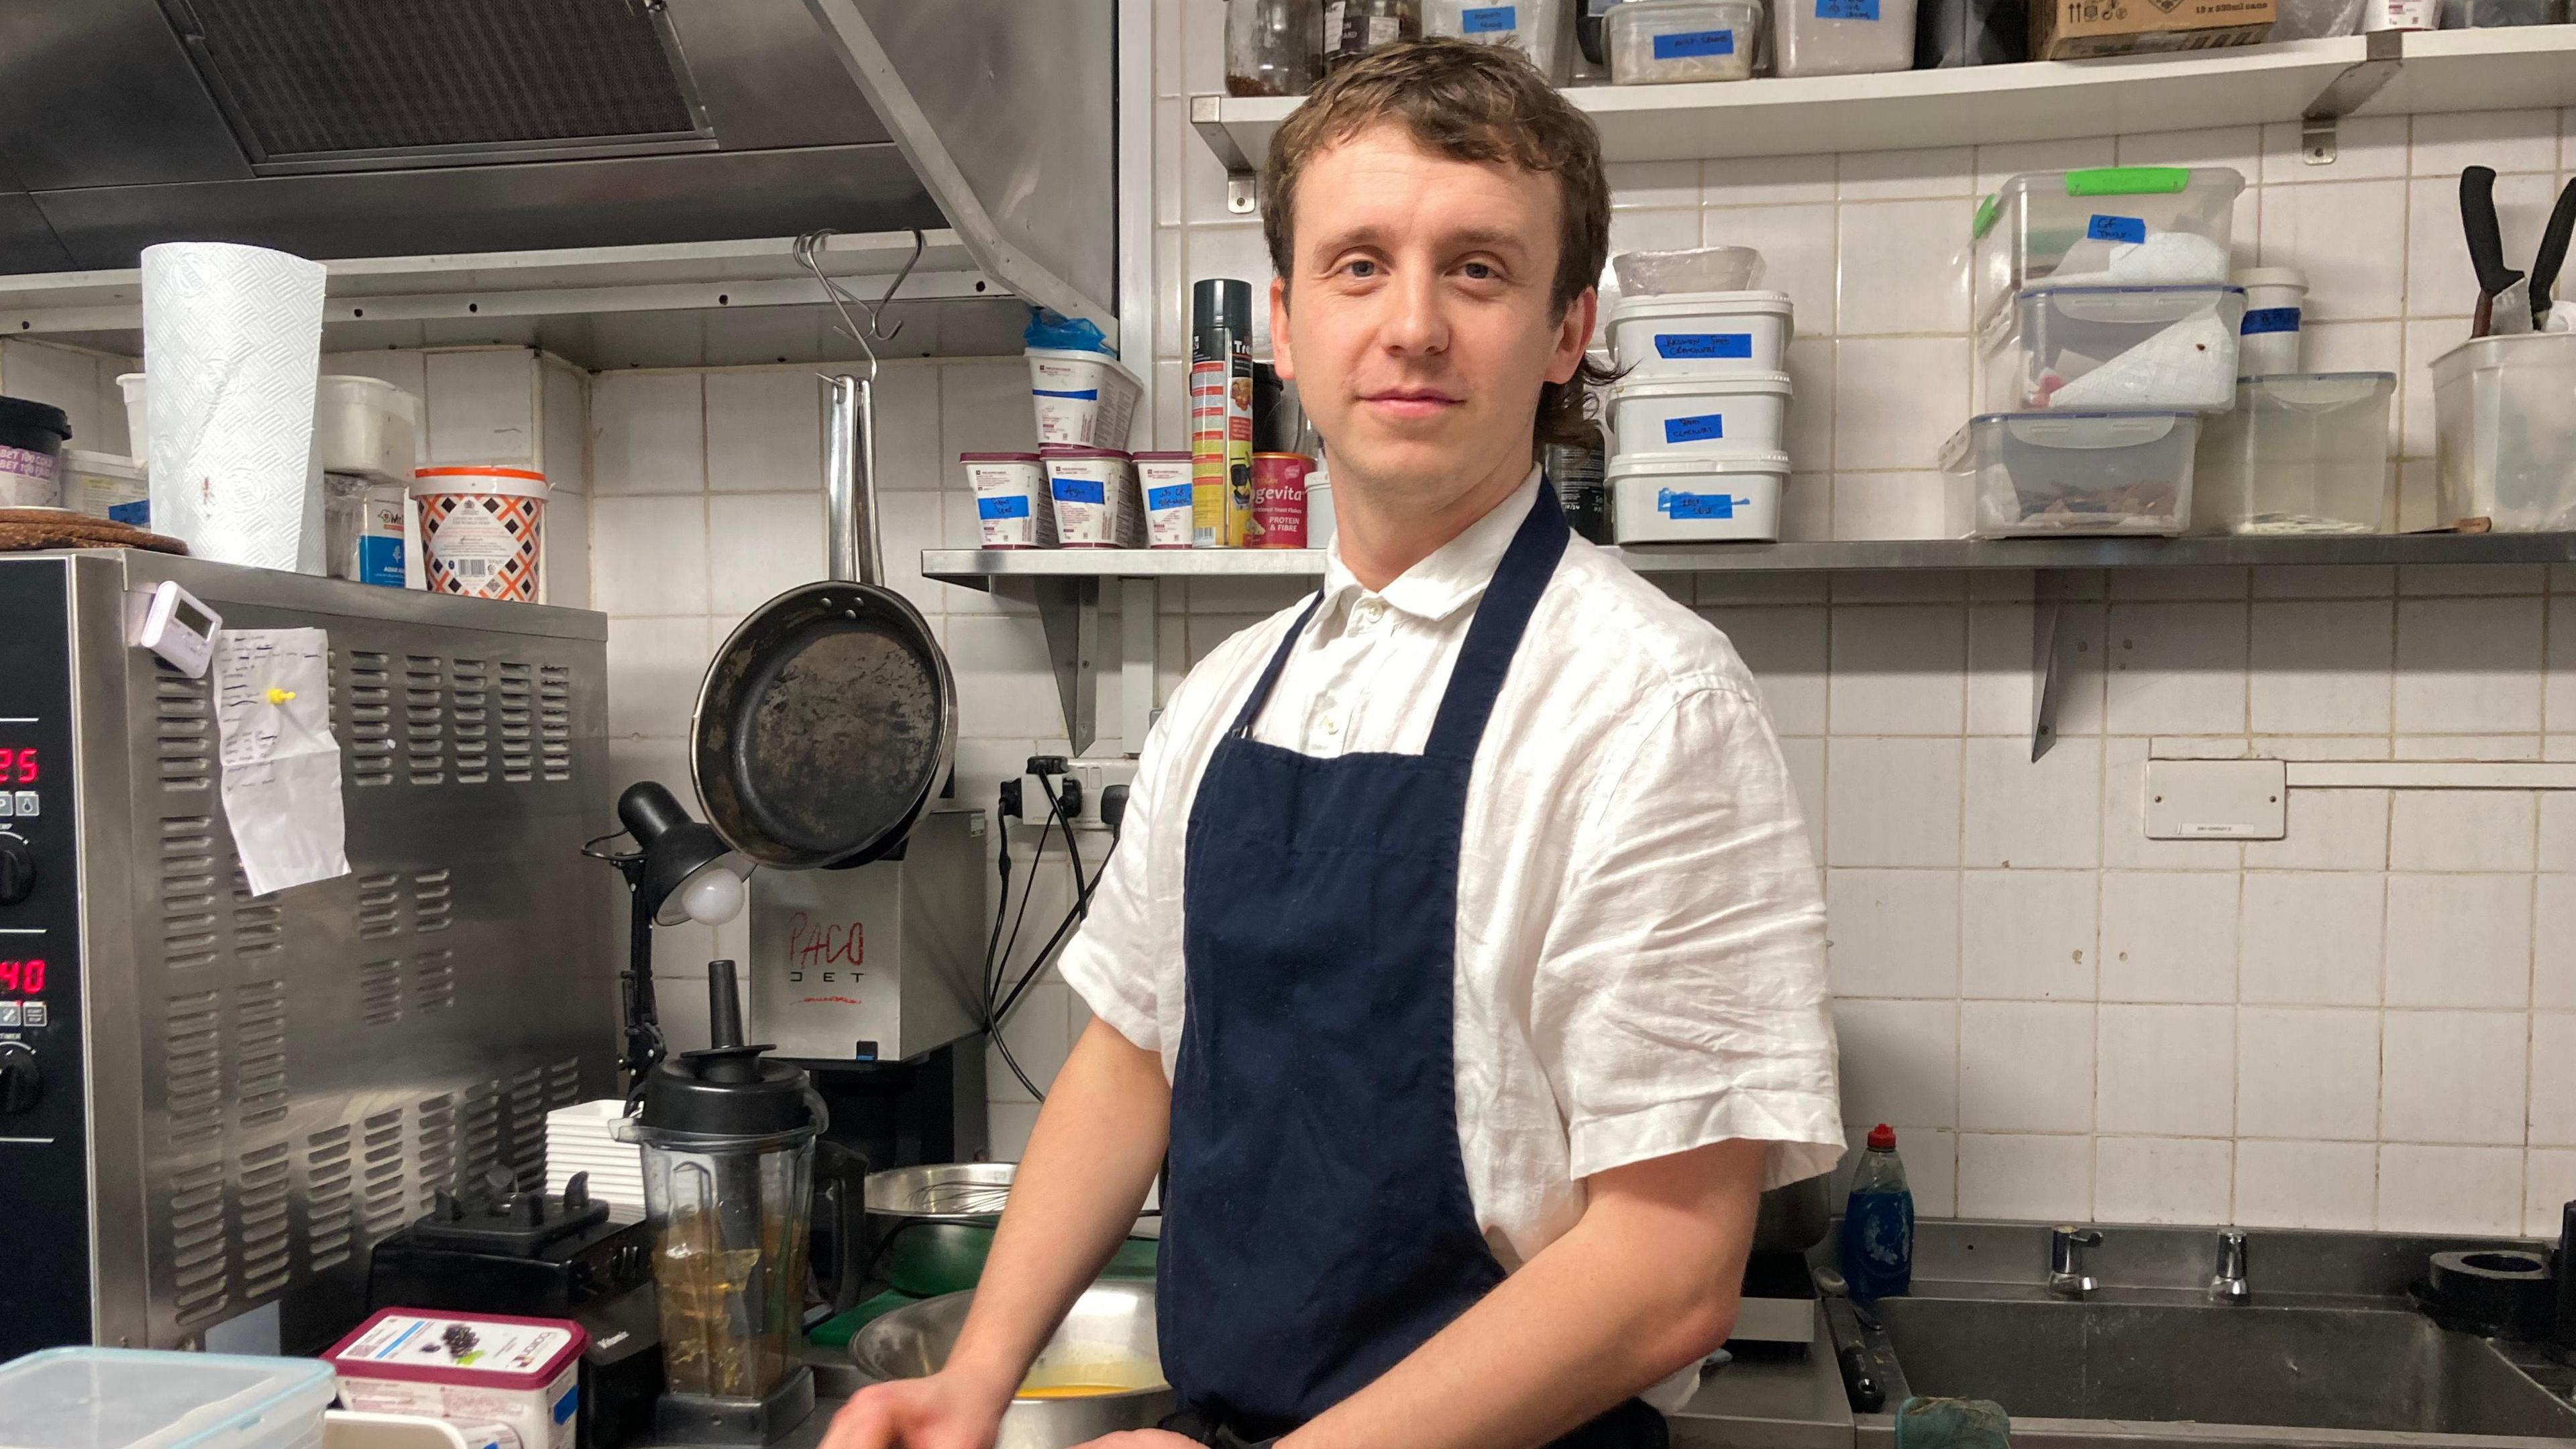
[1263,39,1610,443]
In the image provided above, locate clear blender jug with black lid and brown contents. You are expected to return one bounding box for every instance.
[616,962,827,1444]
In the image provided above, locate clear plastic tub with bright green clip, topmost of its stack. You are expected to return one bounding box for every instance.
[1971,165,2246,320]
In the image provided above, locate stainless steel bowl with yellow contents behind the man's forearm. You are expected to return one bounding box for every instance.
[850,1281,1175,1449]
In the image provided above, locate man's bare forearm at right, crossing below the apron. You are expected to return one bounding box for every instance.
[1283,1142,1764,1449]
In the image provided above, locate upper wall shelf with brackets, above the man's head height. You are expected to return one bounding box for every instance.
[1190,25,2576,179]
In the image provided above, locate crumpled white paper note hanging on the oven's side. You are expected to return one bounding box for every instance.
[214,629,347,895]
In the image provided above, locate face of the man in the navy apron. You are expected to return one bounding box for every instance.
[1270,123,1592,508]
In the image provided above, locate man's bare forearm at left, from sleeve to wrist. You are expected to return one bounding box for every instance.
[948,1021,1172,1397]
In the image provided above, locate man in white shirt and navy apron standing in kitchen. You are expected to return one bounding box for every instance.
[827,41,1842,1449]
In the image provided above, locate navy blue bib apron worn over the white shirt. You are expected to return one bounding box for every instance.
[1154,485,1664,1449]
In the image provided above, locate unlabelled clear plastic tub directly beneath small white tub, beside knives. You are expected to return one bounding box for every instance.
[2192,371,2398,534]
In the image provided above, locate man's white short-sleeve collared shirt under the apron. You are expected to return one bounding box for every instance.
[1061,470,1842,1269]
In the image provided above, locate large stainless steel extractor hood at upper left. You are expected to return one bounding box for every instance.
[0,0,1116,320]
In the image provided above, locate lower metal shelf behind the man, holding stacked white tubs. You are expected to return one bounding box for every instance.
[922,534,2576,588]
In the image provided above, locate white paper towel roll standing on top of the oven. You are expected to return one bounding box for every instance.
[144,242,325,572]
